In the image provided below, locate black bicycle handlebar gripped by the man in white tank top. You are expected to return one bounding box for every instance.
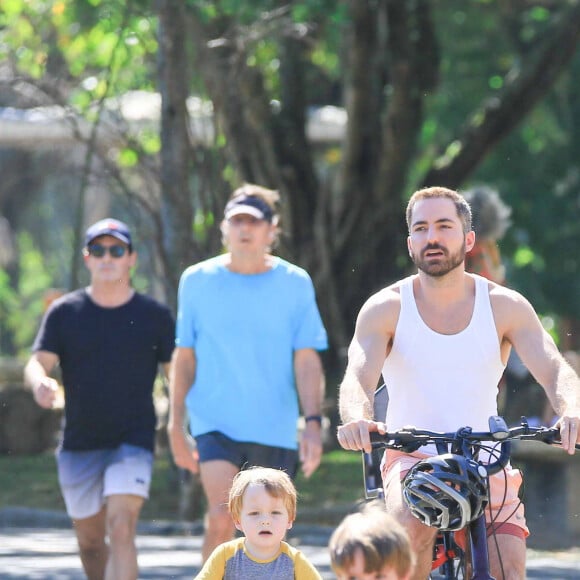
[371,417,580,475]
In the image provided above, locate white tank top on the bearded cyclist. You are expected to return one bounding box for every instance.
[383,275,504,446]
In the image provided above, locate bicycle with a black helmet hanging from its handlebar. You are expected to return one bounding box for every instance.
[363,417,580,580]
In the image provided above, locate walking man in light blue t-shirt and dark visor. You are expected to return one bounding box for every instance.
[168,184,327,561]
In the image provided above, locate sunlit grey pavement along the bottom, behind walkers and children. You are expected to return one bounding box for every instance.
[0,521,580,580]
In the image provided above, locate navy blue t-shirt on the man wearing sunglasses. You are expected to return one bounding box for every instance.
[32,289,175,451]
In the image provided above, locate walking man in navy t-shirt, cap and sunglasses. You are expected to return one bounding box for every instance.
[24,219,175,580]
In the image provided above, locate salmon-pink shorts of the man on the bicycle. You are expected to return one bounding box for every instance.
[381,449,530,539]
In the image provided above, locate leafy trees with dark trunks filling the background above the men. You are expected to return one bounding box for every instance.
[0,0,580,358]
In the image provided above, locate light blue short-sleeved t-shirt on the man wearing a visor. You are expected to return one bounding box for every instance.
[176,256,327,449]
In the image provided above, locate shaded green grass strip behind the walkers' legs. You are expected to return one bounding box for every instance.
[0,451,363,524]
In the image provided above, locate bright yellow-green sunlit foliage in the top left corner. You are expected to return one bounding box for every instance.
[0,0,157,97]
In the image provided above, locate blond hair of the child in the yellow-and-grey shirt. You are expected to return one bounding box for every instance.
[228,467,297,521]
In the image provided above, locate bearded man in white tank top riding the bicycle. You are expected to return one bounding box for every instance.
[338,187,580,580]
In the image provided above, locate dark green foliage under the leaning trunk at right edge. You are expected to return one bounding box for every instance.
[473,49,580,318]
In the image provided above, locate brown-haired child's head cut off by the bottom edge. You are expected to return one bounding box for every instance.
[329,505,414,580]
